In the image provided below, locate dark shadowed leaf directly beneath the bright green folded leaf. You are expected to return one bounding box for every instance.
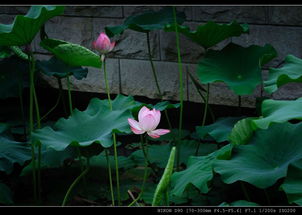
[36,57,88,80]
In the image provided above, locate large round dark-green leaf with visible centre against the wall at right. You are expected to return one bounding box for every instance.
[197,43,277,95]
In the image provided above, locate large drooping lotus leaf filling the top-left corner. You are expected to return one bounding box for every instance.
[0,6,64,46]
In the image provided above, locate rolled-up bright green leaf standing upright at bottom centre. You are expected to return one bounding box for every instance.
[152,146,176,206]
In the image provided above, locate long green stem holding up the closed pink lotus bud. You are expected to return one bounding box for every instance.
[101,57,121,205]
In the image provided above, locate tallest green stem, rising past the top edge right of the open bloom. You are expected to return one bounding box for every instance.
[173,6,184,170]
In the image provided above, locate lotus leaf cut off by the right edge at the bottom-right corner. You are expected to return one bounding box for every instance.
[280,160,302,206]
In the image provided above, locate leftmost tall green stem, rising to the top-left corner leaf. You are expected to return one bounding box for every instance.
[29,48,37,202]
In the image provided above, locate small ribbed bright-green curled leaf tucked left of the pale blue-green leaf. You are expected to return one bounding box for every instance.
[229,117,256,145]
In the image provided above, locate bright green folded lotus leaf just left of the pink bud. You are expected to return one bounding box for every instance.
[40,39,102,68]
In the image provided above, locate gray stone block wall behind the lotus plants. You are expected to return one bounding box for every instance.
[0,5,302,107]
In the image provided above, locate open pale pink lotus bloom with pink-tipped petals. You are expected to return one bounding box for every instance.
[128,106,170,138]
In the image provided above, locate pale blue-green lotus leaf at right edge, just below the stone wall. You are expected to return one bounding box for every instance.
[252,98,302,129]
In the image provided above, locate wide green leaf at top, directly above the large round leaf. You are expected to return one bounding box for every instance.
[164,21,249,48]
